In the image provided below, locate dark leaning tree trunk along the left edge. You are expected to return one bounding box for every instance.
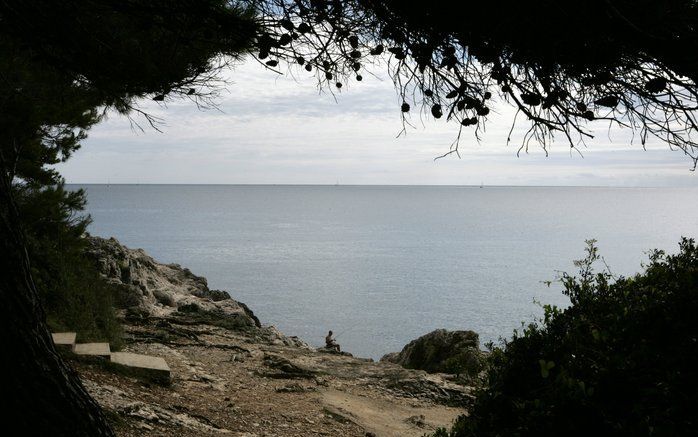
[0,172,114,436]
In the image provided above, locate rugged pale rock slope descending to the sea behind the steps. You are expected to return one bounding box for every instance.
[87,237,261,328]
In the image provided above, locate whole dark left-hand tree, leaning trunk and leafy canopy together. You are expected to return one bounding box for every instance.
[0,0,256,436]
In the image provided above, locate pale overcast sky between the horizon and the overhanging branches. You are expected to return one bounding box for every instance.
[59,62,698,186]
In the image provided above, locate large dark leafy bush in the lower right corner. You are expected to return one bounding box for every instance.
[436,238,698,437]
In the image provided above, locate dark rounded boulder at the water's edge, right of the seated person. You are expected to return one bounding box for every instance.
[381,329,483,376]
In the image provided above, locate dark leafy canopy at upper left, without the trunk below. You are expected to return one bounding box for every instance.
[0,0,255,183]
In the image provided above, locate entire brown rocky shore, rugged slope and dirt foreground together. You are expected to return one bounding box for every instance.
[74,237,476,437]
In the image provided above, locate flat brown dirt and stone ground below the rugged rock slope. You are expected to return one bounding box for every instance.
[75,319,470,437]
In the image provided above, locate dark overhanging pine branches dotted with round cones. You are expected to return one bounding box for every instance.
[250,0,698,167]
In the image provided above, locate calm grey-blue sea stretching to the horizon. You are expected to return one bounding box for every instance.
[72,185,698,358]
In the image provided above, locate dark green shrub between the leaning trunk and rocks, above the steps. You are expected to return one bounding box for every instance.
[15,183,122,349]
